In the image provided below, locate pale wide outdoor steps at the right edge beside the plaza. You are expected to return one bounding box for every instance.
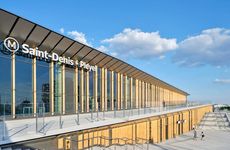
[198,112,230,131]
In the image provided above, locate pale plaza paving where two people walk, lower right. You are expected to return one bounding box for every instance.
[149,129,230,150]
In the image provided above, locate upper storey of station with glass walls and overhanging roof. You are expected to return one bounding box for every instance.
[0,9,188,118]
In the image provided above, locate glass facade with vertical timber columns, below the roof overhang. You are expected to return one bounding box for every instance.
[0,41,187,118]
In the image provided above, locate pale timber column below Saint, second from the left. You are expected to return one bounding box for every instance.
[32,57,37,117]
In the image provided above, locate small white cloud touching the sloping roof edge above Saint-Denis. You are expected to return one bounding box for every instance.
[67,31,91,46]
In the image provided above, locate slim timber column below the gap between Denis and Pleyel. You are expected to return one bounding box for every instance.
[74,67,78,113]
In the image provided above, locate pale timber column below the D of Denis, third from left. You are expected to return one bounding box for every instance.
[49,61,54,115]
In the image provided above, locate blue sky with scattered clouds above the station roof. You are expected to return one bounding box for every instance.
[0,0,230,104]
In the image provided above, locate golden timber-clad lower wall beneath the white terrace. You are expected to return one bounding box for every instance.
[57,105,213,150]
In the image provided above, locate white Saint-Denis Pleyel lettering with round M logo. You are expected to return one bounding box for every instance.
[3,37,96,71]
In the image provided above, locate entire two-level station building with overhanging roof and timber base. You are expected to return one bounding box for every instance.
[0,9,212,150]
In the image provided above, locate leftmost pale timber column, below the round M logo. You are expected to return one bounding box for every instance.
[11,53,16,118]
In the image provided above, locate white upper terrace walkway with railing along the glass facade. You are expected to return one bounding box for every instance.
[0,102,212,141]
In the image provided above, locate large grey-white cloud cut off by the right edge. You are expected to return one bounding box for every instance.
[173,28,230,67]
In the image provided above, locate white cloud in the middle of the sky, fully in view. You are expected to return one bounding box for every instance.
[102,28,177,59]
